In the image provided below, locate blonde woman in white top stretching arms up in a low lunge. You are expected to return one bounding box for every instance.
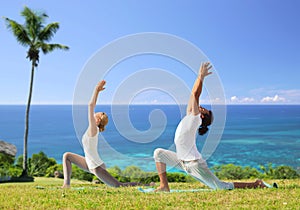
[62,80,144,188]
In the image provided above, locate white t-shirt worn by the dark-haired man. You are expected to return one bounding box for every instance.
[174,113,202,161]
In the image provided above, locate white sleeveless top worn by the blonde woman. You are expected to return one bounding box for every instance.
[82,129,104,169]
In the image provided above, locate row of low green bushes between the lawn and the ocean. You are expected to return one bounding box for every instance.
[0,152,300,183]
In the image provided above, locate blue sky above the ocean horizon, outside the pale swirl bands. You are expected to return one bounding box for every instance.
[0,0,300,104]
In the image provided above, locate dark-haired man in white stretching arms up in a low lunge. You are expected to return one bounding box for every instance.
[154,62,266,191]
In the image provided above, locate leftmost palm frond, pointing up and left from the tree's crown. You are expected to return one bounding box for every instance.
[5,18,31,46]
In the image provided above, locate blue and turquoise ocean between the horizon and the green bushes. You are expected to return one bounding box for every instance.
[0,105,300,171]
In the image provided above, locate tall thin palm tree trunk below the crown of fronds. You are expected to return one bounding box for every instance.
[21,59,36,177]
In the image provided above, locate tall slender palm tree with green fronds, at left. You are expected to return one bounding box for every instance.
[4,7,69,177]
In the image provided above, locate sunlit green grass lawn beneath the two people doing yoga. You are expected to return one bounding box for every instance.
[0,178,300,209]
